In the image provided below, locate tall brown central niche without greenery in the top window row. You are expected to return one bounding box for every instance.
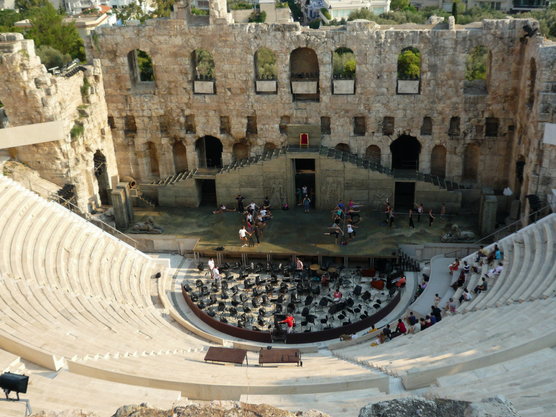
[290,48,319,101]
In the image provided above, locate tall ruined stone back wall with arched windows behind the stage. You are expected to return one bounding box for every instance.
[87,15,548,193]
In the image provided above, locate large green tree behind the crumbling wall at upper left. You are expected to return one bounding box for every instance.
[25,3,85,61]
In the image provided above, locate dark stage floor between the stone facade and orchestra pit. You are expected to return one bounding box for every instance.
[124,202,481,259]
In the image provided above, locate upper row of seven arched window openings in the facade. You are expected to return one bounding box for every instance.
[128,45,492,84]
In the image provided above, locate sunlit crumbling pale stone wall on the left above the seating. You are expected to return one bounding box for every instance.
[0,34,117,211]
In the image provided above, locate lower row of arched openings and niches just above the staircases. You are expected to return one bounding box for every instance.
[143,135,480,182]
